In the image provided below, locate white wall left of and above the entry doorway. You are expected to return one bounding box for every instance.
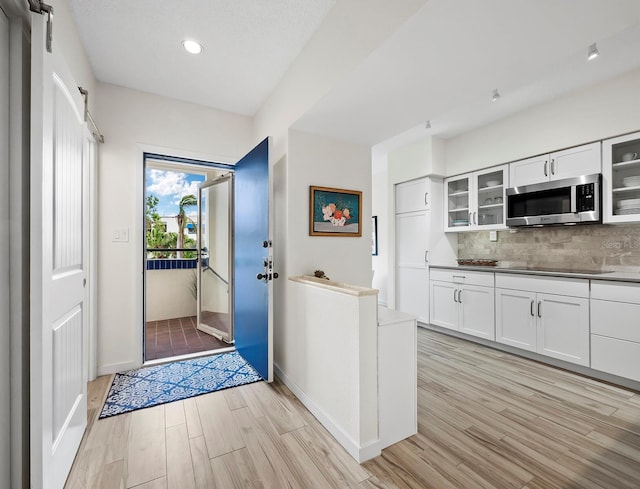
[96,84,252,374]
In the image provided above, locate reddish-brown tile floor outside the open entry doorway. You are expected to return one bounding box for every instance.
[144,316,233,361]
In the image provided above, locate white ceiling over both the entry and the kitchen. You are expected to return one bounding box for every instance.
[69,0,640,145]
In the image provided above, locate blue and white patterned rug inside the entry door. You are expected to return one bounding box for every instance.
[100,351,262,418]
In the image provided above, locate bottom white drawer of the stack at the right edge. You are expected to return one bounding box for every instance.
[591,334,640,381]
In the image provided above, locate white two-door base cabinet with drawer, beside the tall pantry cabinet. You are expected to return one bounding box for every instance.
[430,268,495,340]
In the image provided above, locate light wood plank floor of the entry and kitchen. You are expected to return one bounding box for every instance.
[66,329,640,489]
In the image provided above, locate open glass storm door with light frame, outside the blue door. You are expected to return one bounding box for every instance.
[197,173,234,344]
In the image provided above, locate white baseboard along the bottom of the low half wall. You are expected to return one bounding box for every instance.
[273,363,381,463]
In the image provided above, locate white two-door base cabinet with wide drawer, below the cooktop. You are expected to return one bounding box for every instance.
[495,274,589,366]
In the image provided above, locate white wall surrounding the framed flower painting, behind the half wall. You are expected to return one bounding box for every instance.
[273,127,372,374]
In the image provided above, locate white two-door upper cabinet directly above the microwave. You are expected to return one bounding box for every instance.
[509,142,602,187]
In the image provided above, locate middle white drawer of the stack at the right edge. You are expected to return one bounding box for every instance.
[591,299,640,343]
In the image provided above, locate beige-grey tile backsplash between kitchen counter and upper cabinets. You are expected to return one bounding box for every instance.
[458,224,640,272]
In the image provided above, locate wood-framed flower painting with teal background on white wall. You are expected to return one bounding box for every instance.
[309,185,362,238]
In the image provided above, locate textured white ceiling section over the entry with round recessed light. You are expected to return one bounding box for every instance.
[69,0,335,115]
